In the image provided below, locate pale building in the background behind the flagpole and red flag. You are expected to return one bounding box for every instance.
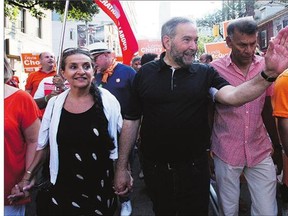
[52,9,121,57]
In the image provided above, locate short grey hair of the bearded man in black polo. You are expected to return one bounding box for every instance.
[161,17,194,48]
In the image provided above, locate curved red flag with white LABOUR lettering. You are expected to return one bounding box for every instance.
[94,0,138,65]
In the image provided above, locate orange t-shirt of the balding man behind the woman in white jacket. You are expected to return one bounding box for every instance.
[25,69,56,97]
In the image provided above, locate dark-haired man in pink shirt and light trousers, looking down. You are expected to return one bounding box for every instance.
[211,17,277,216]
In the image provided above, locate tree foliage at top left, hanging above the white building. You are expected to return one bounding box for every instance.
[4,0,99,21]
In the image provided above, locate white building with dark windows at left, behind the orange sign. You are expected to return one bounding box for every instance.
[4,9,53,89]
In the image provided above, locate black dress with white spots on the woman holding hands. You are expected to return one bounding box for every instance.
[40,106,117,215]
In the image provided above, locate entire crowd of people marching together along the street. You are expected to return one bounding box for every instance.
[4,14,288,216]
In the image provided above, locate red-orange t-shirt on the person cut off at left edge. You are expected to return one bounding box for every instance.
[4,90,41,205]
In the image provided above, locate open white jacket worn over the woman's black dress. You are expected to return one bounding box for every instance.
[37,88,123,184]
